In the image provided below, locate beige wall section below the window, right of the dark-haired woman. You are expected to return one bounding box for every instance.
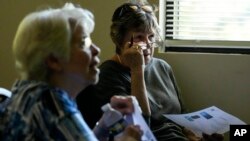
[156,53,250,121]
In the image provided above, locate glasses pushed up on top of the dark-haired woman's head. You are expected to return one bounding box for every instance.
[119,4,154,17]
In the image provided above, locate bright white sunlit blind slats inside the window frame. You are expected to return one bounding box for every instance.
[166,0,250,41]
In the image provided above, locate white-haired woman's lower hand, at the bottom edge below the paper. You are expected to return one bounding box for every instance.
[115,125,143,141]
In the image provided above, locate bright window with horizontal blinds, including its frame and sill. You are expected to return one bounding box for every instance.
[159,0,250,53]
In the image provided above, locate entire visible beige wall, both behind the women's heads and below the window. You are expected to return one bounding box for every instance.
[0,0,250,135]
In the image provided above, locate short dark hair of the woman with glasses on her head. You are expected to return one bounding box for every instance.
[110,3,160,54]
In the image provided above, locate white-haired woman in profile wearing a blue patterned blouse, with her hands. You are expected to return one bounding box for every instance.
[0,4,141,141]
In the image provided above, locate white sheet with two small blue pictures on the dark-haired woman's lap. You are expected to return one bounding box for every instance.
[164,106,246,136]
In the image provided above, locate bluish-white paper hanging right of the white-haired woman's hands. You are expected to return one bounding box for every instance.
[125,97,157,141]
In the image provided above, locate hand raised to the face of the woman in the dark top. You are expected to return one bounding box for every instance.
[121,42,144,69]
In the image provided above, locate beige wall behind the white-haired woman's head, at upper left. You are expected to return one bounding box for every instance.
[0,0,127,88]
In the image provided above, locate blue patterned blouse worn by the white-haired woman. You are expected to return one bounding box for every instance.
[0,80,97,141]
